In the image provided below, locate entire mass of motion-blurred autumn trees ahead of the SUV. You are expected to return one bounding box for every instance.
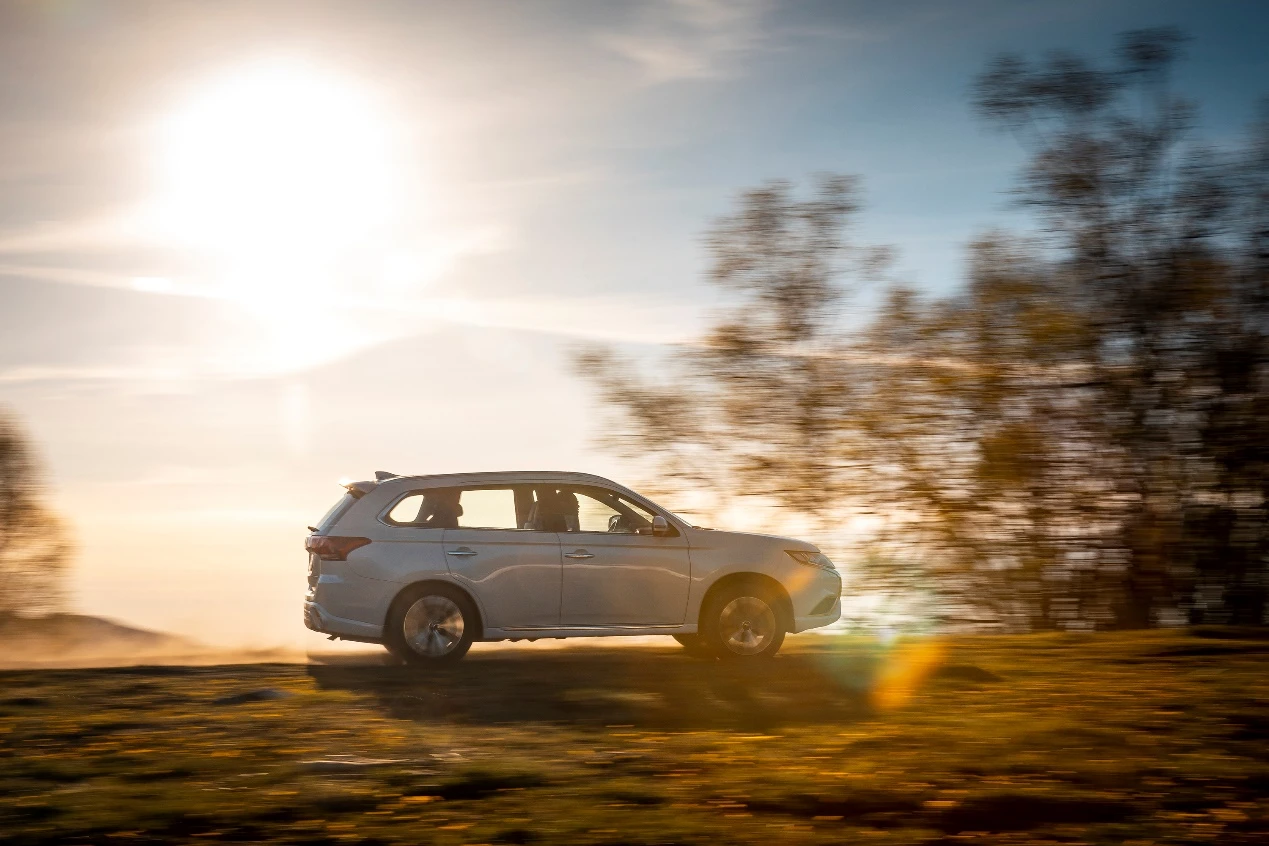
[580,29,1269,629]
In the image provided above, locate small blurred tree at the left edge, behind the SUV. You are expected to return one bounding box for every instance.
[0,412,70,616]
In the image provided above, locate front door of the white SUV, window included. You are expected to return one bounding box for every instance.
[560,487,692,628]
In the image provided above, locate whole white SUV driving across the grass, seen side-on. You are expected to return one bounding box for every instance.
[305,472,841,663]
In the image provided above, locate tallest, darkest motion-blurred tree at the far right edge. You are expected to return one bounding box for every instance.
[977,29,1269,627]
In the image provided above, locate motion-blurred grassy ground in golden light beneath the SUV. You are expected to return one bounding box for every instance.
[0,630,1269,845]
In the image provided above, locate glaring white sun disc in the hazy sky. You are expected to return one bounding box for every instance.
[154,61,402,297]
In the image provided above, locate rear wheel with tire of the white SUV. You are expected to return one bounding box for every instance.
[383,585,480,665]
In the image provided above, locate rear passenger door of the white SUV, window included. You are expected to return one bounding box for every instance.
[442,486,561,629]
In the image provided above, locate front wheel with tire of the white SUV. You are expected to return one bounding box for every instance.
[700,581,787,662]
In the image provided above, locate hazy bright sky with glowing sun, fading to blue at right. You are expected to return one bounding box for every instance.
[0,0,1269,647]
